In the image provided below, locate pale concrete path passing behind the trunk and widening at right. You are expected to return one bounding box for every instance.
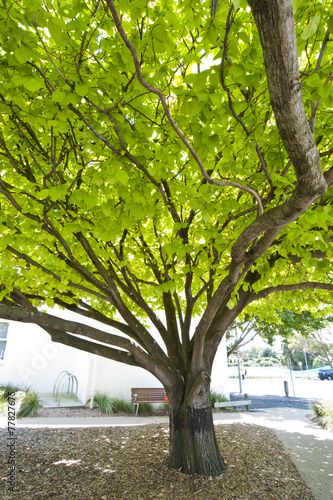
[0,408,333,500]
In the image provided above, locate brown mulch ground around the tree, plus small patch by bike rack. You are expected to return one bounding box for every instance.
[0,409,314,500]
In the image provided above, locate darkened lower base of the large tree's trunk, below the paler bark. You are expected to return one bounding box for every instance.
[168,406,227,476]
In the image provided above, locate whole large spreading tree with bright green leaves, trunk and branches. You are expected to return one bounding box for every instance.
[0,0,333,475]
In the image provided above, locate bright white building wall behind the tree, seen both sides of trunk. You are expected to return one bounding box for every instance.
[0,317,228,403]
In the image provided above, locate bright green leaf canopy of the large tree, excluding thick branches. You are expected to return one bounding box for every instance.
[0,0,333,330]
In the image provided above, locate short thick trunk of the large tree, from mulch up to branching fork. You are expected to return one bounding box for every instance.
[169,372,227,476]
